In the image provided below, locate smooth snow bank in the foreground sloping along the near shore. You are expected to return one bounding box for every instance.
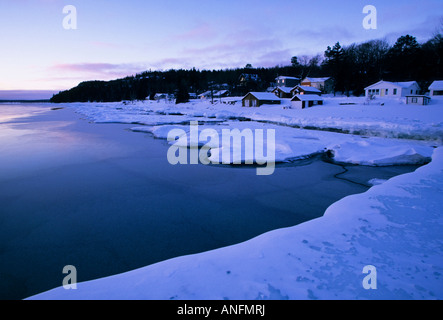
[30,148,443,300]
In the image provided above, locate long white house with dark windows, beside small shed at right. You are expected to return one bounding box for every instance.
[365,80,420,98]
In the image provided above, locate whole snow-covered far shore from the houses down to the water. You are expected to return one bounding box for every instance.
[64,97,443,165]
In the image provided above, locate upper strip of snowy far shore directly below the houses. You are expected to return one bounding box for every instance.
[70,97,443,144]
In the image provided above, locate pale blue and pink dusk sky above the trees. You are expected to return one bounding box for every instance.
[0,0,443,94]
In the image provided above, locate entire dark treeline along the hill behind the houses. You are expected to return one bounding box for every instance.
[51,34,443,103]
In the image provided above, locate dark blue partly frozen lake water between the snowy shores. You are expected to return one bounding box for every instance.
[0,104,422,299]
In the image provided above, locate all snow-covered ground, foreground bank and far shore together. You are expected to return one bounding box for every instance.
[27,98,443,299]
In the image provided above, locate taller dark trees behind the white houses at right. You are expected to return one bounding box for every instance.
[322,34,443,96]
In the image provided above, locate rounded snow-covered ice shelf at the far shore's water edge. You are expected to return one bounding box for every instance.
[132,121,433,166]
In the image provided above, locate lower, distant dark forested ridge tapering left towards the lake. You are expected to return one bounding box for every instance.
[51,65,304,103]
